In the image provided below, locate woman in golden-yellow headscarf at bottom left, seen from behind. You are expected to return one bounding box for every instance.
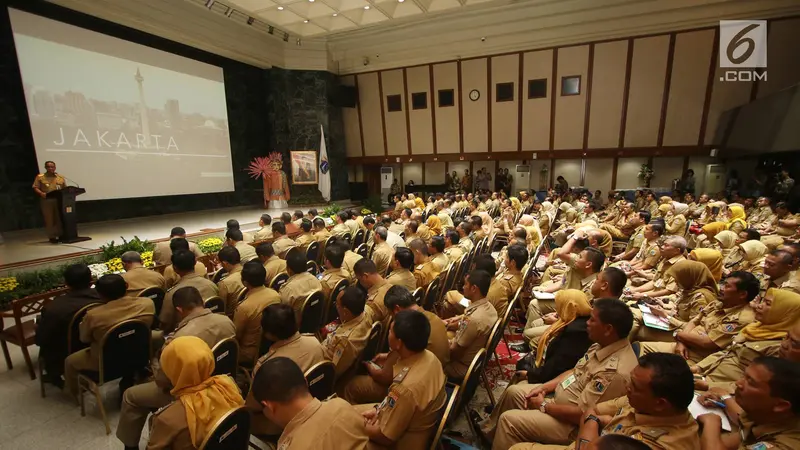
[147,336,244,450]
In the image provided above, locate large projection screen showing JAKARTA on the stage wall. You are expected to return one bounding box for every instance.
[9,8,234,200]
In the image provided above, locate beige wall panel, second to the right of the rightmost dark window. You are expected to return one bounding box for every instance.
[625,35,669,147]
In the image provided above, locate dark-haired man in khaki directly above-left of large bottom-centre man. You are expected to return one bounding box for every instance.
[322,286,372,382]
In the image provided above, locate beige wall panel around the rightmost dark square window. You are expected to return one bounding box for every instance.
[553,45,589,150]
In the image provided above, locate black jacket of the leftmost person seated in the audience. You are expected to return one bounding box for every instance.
[36,289,102,363]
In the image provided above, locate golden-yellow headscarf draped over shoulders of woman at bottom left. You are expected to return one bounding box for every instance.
[160,336,244,447]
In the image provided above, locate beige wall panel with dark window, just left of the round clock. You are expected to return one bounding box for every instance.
[434,62,461,155]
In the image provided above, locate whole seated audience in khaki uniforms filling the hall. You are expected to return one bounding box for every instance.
[28,185,800,450]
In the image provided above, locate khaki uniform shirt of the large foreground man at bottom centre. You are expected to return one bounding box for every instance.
[376,350,447,449]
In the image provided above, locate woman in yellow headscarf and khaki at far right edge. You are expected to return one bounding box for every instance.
[692,289,800,390]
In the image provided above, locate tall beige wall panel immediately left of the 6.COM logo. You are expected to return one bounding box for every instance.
[664,30,715,145]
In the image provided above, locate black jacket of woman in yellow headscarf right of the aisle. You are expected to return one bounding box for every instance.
[517,316,592,384]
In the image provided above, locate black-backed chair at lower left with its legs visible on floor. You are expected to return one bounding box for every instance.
[78,319,151,435]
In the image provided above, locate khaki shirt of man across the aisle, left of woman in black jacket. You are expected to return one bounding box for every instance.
[448,298,497,373]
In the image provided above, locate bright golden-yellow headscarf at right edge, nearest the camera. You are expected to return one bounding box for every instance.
[737,289,800,341]
